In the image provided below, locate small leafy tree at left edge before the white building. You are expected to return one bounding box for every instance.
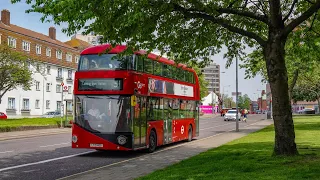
[0,45,32,103]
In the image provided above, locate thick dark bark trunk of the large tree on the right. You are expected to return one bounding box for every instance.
[264,34,298,156]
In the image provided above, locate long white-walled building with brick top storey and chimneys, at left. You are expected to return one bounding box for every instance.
[0,10,88,117]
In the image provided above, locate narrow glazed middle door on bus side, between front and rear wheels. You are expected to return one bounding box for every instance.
[163,99,173,144]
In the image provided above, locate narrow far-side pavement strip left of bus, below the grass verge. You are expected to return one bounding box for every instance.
[0,128,71,141]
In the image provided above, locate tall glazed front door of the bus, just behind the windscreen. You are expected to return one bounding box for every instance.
[133,96,147,148]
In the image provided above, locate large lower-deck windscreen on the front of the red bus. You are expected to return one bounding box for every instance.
[75,95,132,133]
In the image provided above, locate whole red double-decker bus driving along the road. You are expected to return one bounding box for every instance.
[72,44,200,152]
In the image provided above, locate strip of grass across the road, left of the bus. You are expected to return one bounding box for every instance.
[0,117,70,132]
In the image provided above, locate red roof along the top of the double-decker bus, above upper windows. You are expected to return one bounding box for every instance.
[80,44,195,73]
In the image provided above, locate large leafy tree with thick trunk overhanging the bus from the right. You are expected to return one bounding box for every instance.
[15,0,320,155]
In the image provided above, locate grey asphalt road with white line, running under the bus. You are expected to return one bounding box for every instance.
[0,115,262,180]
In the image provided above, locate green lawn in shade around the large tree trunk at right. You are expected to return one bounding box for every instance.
[139,116,320,180]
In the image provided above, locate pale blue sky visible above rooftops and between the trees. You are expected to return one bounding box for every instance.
[0,0,266,100]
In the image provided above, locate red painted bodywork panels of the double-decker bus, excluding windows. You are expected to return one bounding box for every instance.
[72,45,200,151]
